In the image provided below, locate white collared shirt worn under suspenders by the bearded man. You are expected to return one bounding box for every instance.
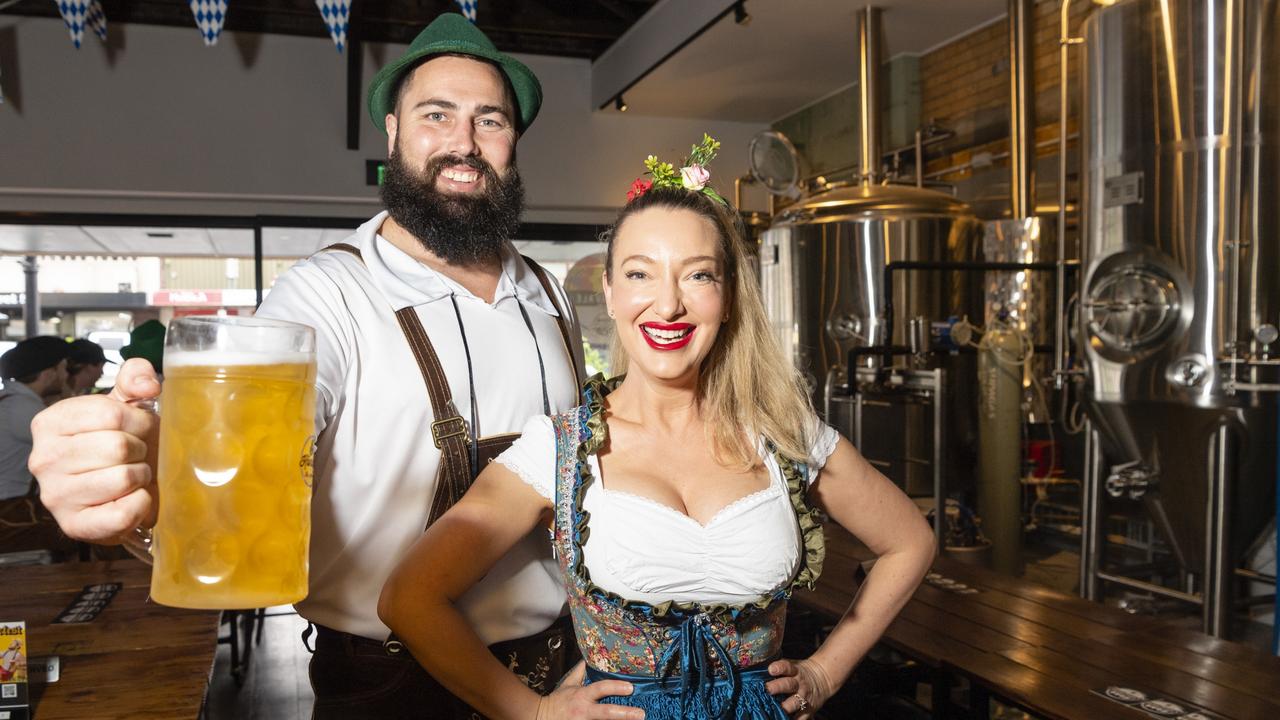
[259,213,582,644]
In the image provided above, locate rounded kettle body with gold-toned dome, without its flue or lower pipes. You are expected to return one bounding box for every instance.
[760,184,982,409]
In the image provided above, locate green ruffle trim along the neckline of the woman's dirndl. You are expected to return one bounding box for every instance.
[570,373,827,623]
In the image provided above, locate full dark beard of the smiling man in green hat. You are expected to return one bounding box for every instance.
[381,149,525,265]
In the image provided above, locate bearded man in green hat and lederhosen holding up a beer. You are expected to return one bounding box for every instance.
[32,14,581,719]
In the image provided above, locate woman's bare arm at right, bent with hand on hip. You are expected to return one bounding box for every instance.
[769,438,936,717]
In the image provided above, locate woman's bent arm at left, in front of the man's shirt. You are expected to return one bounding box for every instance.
[378,462,550,719]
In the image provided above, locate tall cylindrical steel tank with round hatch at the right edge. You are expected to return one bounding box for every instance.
[1078,0,1280,571]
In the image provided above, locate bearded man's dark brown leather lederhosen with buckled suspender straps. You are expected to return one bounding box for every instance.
[314,243,580,720]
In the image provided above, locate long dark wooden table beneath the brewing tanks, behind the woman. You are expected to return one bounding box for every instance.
[794,524,1280,720]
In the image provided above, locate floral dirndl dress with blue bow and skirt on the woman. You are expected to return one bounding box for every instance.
[552,375,824,720]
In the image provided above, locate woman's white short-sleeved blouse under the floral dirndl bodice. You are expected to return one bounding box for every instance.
[497,416,840,605]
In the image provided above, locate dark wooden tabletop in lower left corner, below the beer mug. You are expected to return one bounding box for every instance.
[0,560,218,720]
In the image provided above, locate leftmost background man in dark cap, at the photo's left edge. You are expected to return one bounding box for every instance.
[0,336,69,501]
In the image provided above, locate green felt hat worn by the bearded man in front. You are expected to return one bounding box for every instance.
[369,13,543,132]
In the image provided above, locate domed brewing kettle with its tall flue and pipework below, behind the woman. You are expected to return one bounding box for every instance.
[753,8,982,537]
